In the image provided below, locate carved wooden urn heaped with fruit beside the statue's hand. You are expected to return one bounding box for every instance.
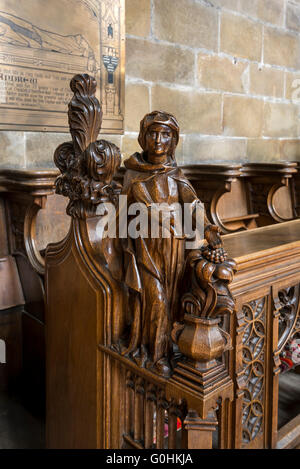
[172,225,236,371]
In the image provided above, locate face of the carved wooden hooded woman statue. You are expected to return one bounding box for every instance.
[146,124,173,162]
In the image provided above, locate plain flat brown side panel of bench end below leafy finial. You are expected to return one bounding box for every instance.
[46,250,100,448]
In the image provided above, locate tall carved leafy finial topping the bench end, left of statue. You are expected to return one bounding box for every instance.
[54,74,121,218]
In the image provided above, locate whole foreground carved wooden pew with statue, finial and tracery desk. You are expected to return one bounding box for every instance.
[46,75,300,449]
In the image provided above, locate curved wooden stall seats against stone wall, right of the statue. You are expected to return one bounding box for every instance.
[182,161,298,234]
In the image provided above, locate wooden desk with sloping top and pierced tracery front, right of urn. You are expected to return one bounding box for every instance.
[224,220,300,449]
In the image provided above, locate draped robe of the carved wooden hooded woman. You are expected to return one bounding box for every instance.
[122,153,204,364]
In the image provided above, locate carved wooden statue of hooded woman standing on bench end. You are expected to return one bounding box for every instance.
[116,111,206,376]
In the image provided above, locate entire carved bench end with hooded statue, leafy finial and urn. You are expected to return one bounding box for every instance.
[46,75,235,448]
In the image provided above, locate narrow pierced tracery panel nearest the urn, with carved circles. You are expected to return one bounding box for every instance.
[242,297,267,446]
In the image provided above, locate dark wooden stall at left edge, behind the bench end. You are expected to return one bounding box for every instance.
[0,169,68,410]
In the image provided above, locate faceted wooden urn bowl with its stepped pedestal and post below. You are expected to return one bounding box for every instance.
[167,314,233,449]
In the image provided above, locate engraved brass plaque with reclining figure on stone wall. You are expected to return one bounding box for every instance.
[0,0,125,134]
